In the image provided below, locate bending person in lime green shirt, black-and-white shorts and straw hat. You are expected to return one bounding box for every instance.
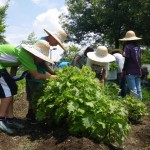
[0,40,57,134]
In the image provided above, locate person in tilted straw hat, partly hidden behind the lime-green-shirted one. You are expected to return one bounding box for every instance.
[26,28,67,124]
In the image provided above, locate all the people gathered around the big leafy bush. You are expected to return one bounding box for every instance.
[0,29,142,134]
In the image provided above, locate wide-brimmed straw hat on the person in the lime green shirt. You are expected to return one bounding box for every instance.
[21,40,54,64]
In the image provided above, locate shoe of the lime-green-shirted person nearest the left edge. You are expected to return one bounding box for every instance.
[0,119,15,135]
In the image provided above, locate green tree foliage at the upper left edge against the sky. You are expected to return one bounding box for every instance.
[0,4,8,44]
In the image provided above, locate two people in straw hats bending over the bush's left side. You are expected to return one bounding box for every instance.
[0,29,67,134]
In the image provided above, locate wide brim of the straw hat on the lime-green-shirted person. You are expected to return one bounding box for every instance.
[21,44,54,64]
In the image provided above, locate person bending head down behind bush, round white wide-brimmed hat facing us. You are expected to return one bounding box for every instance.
[86,46,115,82]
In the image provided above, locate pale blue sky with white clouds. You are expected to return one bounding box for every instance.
[0,0,66,61]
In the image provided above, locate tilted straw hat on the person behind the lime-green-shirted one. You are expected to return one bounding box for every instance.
[44,29,67,50]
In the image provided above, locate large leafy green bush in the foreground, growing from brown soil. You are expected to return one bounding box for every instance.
[35,66,130,144]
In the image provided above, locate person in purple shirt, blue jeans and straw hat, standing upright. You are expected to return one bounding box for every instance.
[119,30,142,100]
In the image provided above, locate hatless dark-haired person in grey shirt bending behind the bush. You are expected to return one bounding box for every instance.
[71,47,94,69]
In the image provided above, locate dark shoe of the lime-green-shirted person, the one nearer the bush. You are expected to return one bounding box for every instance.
[7,117,24,129]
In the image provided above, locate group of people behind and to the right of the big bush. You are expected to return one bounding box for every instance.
[71,30,142,100]
